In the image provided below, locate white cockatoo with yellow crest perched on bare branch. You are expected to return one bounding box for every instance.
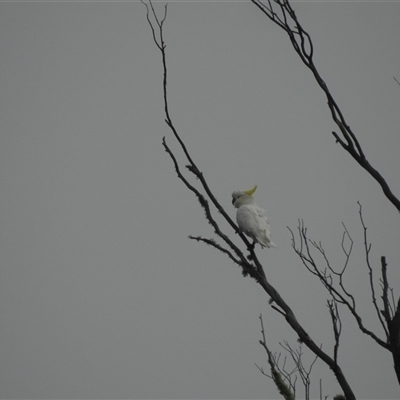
[232,185,276,247]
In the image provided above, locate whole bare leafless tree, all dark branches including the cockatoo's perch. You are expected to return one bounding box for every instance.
[142,0,400,400]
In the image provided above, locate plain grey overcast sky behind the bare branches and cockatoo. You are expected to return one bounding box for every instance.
[0,1,400,399]
